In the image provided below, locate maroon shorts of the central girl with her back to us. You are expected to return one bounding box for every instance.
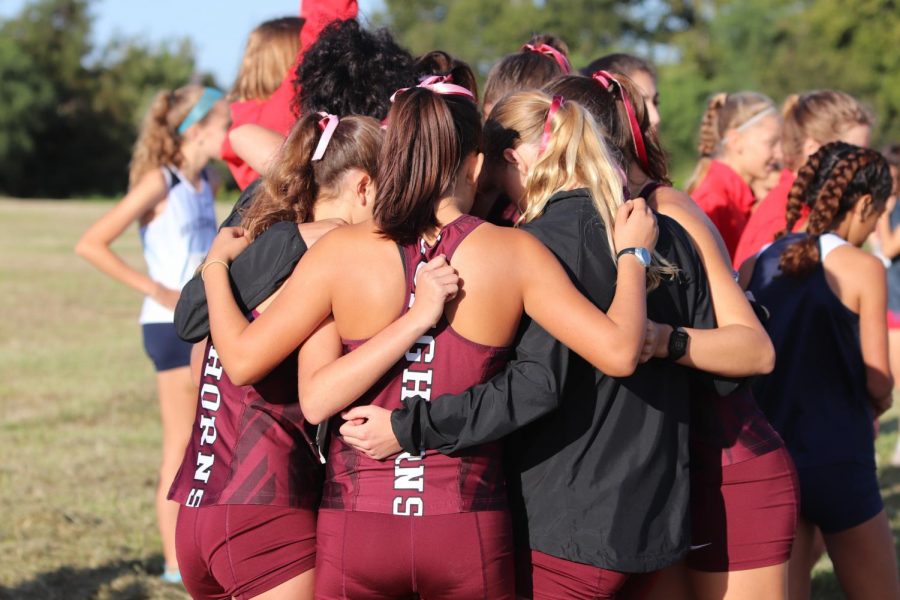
[316,509,515,600]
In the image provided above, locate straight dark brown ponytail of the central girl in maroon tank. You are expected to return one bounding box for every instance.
[374,87,481,243]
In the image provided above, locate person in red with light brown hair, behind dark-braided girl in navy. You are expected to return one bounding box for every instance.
[734,90,875,268]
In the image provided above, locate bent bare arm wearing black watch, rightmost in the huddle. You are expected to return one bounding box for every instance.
[655,188,775,377]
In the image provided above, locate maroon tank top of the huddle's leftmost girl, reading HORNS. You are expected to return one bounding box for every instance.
[169,315,324,508]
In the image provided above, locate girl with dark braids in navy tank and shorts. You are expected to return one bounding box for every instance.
[741,142,900,599]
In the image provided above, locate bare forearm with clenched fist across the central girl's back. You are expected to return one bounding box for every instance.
[298,256,459,425]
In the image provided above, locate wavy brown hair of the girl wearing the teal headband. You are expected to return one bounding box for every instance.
[128,85,203,188]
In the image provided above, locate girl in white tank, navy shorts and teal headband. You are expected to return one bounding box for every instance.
[75,85,228,582]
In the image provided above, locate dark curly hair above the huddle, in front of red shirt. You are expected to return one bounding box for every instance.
[293,19,416,120]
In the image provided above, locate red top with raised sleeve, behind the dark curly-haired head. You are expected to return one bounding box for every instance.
[221,0,358,190]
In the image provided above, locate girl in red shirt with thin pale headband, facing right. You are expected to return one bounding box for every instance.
[686,92,781,259]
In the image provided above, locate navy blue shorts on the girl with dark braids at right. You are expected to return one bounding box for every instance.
[797,462,884,533]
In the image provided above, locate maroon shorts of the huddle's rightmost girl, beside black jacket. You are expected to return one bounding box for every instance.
[687,448,800,572]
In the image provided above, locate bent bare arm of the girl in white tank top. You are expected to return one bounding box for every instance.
[75,170,178,309]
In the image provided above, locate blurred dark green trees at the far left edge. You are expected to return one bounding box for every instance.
[0,0,216,198]
